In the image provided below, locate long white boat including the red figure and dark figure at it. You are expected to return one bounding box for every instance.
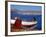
[11,18,37,28]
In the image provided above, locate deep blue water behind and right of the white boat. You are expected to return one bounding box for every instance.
[11,13,42,30]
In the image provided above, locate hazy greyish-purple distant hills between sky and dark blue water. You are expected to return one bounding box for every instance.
[11,9,42,15]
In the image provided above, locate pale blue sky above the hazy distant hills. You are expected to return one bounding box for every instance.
[11,5,41,11]
